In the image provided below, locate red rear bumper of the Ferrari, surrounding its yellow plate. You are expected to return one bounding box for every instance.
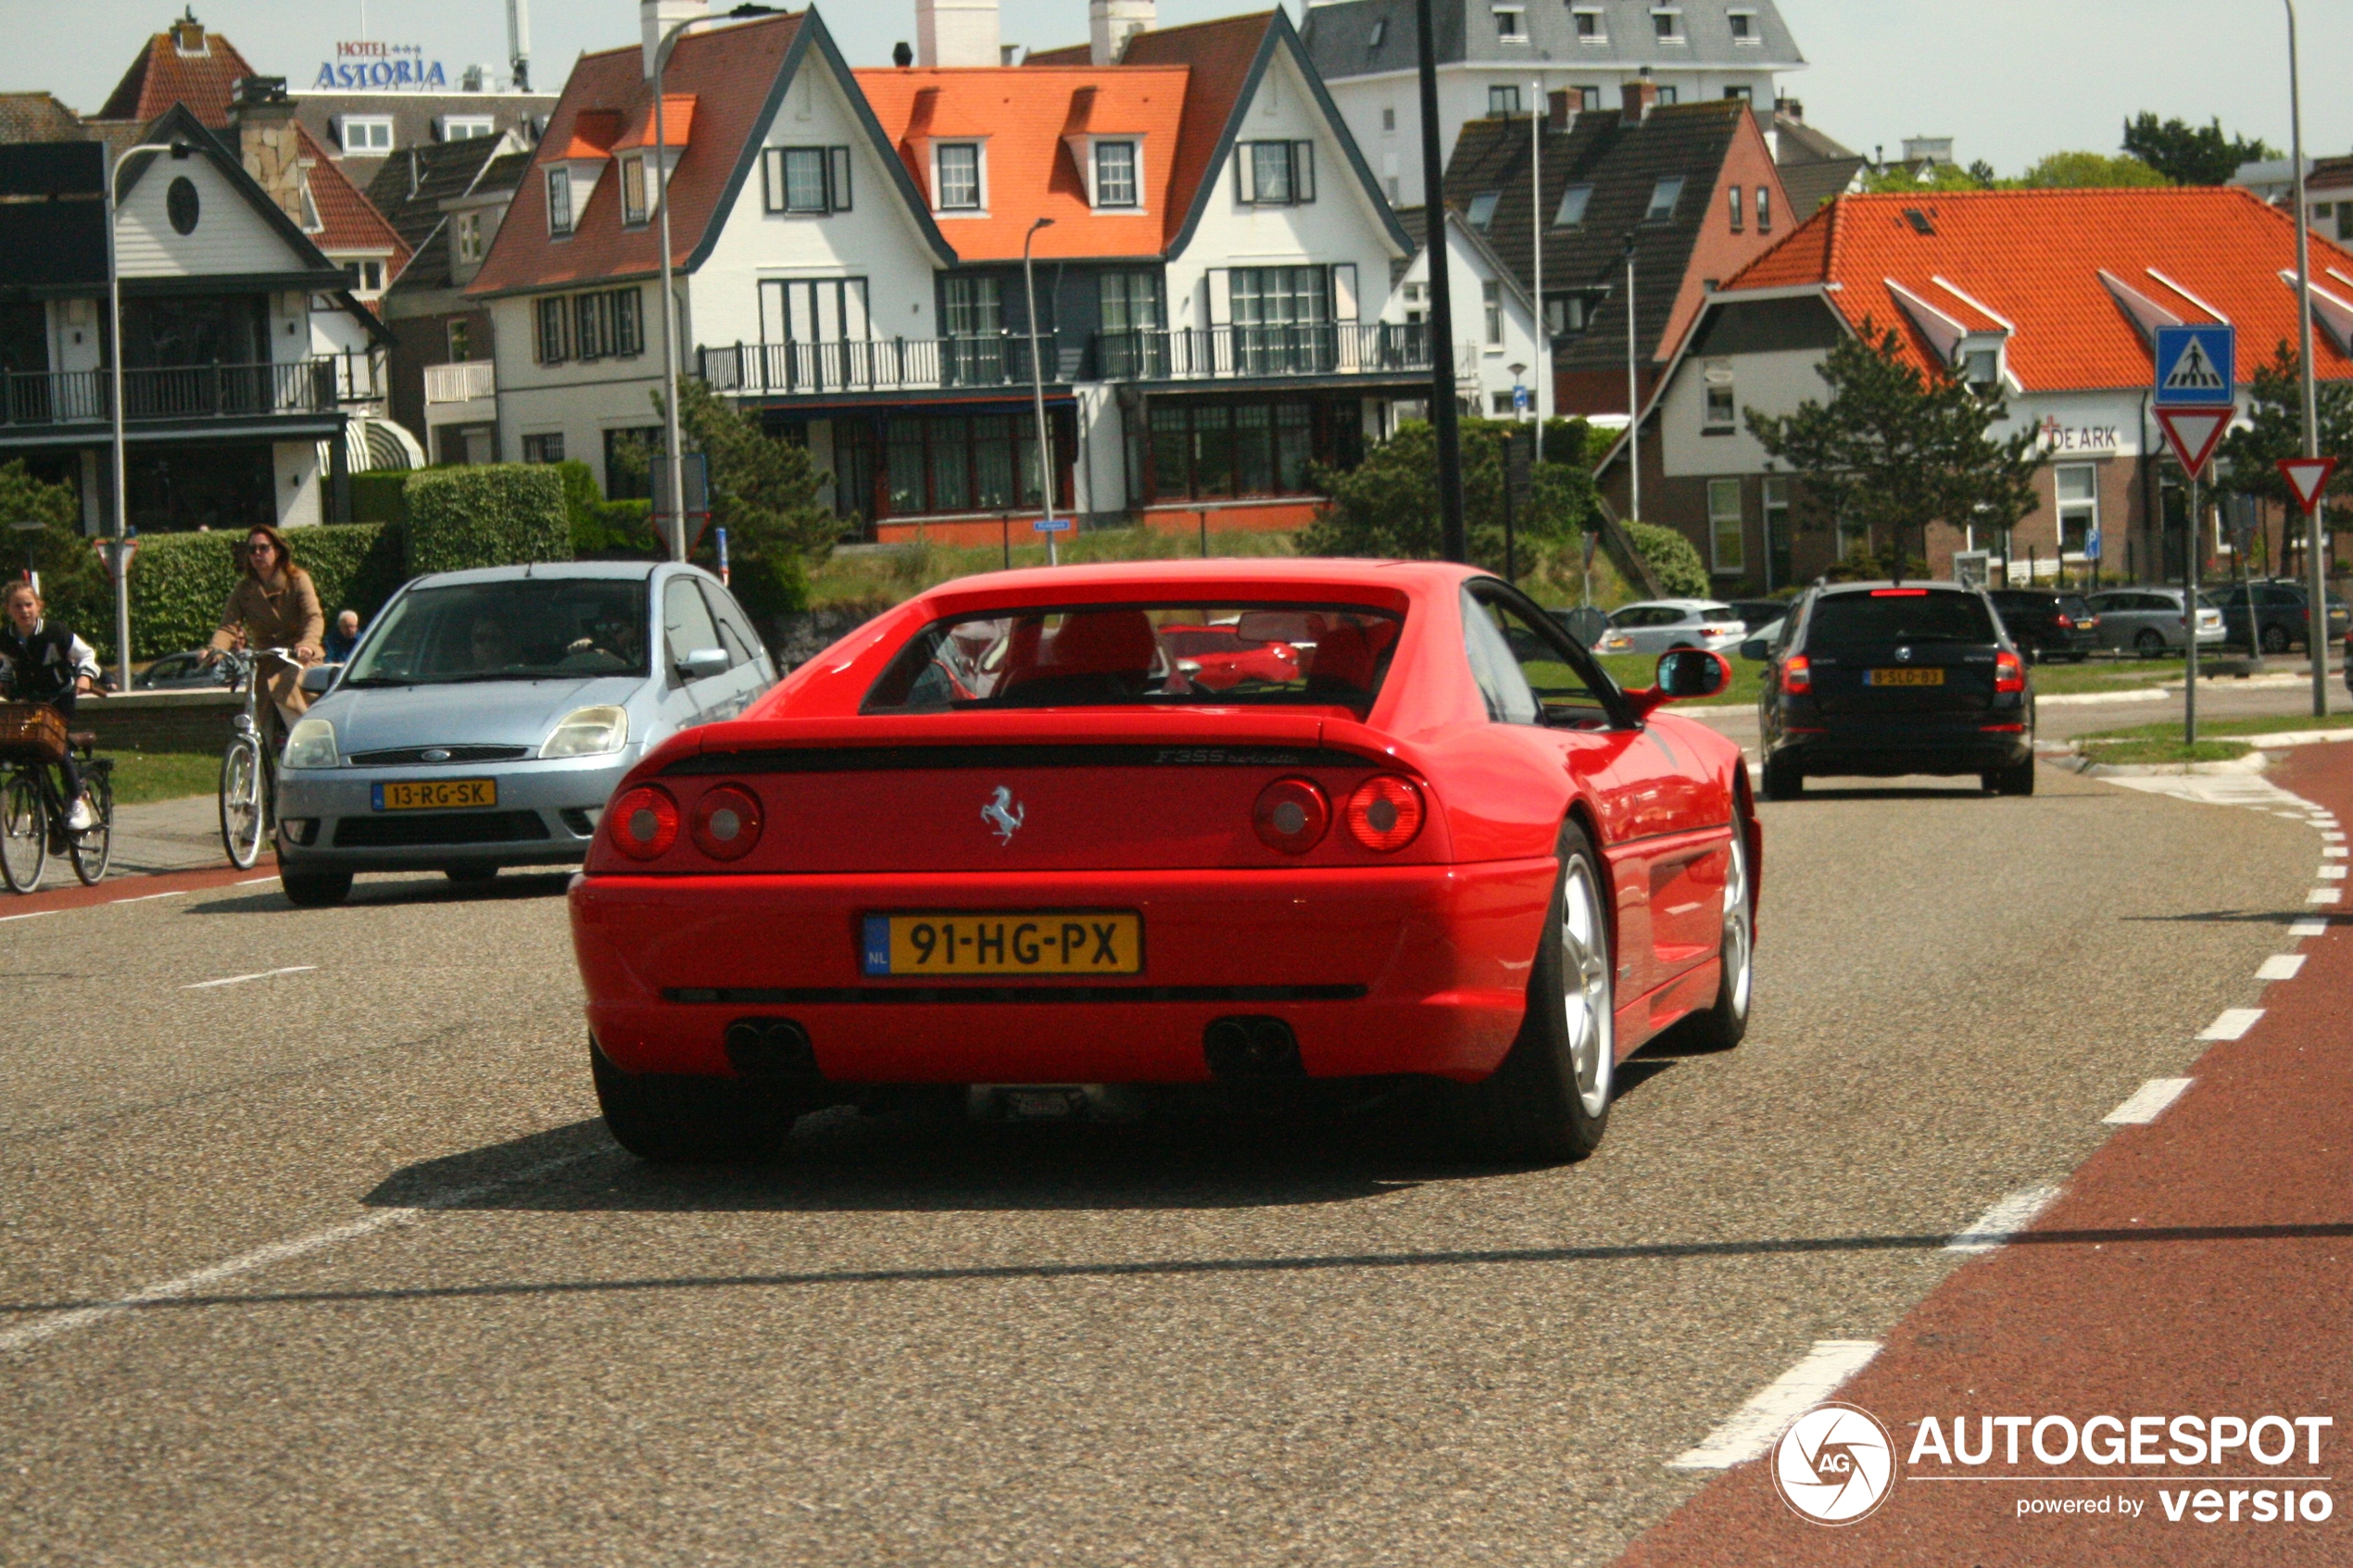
[572,860,1557,1084]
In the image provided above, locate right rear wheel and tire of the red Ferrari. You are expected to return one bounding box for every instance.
[1459,822,1617,1163]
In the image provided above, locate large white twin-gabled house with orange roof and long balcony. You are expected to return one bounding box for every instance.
[468,0,1428,541]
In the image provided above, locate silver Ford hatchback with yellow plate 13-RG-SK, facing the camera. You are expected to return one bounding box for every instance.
[278,562,776,905]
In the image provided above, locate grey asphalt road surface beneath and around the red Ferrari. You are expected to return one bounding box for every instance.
[0,752,2315,1565]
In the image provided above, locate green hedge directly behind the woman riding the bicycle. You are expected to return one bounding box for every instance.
[127,521,409,659]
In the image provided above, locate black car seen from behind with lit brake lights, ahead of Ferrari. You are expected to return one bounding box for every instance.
[1757,583,2035,799]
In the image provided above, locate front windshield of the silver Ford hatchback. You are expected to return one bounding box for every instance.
[344,578,649,686]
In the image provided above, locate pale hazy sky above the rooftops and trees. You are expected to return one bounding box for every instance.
[0,0,2353,174]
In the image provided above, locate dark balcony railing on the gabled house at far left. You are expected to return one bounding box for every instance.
[0,355,347,428]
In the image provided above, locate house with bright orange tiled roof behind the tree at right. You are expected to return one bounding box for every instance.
[1603,188,2353,595]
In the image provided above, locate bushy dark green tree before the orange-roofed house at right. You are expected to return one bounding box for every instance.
[1742,318,2043,569]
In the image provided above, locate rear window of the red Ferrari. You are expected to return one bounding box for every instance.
[863,604,1403,712]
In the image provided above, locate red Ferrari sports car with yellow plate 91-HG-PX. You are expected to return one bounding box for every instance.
[572,559,1762,1159]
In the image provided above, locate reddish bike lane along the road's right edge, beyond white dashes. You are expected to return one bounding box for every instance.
[1621,746,2353,1568]
